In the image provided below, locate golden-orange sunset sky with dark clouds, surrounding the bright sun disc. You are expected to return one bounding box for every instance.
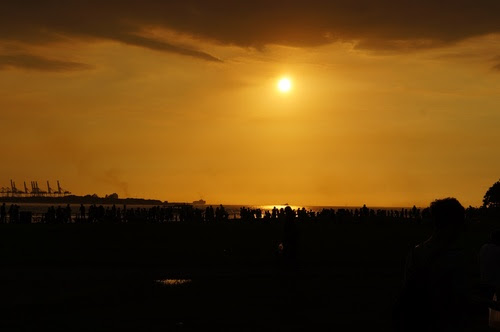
[0,0,500,206]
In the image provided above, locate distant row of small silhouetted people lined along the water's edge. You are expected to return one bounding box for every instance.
[0,203,494,224]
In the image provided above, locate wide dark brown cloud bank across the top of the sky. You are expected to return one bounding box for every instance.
[0,0,500,61]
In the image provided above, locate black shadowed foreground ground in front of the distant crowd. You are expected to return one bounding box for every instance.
[0,222,495,331]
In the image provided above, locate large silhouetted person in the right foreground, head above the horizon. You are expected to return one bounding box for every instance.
[395,198,468,332]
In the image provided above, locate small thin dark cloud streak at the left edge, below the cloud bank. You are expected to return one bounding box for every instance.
[0,54,91,72]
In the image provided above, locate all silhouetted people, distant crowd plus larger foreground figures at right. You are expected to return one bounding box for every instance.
[0,198,500,332]
